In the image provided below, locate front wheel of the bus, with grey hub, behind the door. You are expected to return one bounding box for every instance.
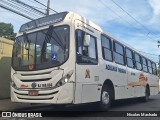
[99,85,113,111]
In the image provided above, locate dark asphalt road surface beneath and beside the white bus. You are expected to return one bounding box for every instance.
[0,95,160,120]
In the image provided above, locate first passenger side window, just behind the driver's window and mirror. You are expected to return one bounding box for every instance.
[101,35,113,61]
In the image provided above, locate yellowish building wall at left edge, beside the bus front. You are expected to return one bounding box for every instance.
[0,37,13,99]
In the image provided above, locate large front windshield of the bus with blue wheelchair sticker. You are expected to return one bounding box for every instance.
[12,26,69,71]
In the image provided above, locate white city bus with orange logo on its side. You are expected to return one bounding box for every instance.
[11,12,159,110]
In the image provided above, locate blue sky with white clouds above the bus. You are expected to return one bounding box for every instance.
[0,0,160,62]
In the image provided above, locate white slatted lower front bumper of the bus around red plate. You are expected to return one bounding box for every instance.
[11,83,74,104]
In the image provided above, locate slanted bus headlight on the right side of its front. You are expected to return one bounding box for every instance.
[55,71,73,87]
